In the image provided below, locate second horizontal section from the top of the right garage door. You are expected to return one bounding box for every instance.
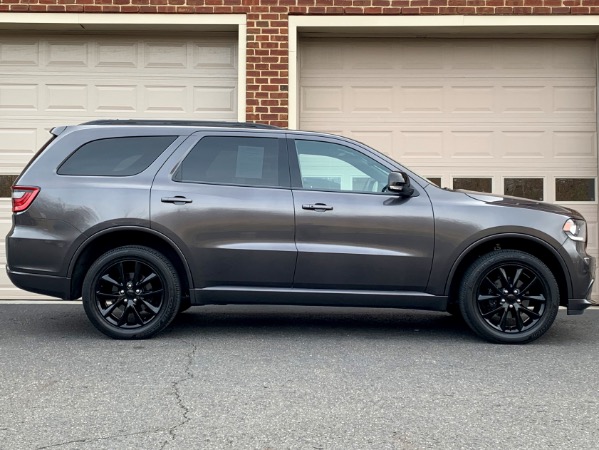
[300,76,596,123]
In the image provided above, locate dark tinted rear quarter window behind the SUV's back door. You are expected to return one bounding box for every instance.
[58,136,177,177]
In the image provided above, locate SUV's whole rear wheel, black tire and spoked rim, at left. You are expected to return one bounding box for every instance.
[82,245,181,339]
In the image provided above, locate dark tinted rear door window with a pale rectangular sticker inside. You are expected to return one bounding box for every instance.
[173,136,289,187]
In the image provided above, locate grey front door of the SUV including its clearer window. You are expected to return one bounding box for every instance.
[290,138,434,292]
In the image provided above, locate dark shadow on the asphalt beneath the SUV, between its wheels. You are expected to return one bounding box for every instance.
[165,305,477,341]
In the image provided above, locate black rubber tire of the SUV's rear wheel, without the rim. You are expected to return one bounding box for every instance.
[82,246,181,339]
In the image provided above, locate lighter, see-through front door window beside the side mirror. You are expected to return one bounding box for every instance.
[295,140,389,192]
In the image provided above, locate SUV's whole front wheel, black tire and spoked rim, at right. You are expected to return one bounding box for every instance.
[459,250,559,344]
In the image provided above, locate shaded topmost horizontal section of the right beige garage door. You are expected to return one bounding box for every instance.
[301,38,595,79]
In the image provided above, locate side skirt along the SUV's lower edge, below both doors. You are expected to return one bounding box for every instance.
[191,286,447,311]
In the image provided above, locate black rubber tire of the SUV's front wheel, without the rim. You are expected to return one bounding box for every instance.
[460,250,559,344]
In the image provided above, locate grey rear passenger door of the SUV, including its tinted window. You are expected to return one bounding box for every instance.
[151,131,297,288]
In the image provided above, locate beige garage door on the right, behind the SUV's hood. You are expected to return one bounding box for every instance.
[300,38,598,298]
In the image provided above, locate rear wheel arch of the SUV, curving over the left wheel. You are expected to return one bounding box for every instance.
[68,226,193,299]
